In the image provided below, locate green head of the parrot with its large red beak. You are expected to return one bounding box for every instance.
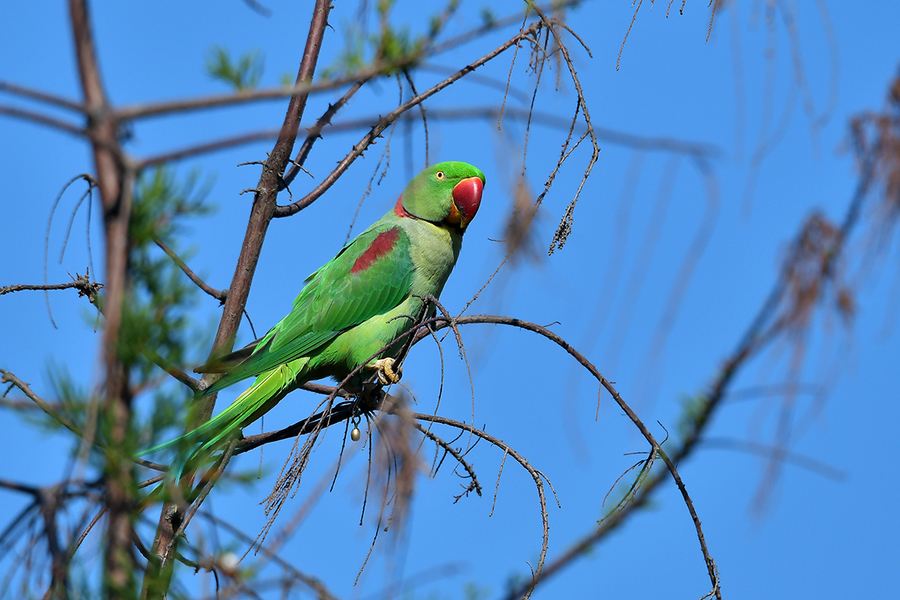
[395,161,485,231]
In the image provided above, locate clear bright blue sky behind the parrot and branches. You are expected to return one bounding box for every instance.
[0,0,900,598]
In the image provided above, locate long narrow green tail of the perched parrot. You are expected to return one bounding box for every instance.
[140,358,309,480]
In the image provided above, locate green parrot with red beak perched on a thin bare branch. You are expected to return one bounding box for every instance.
[142,162,485,471]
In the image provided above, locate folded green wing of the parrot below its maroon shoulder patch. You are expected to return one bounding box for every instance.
[198,223,414,394]
